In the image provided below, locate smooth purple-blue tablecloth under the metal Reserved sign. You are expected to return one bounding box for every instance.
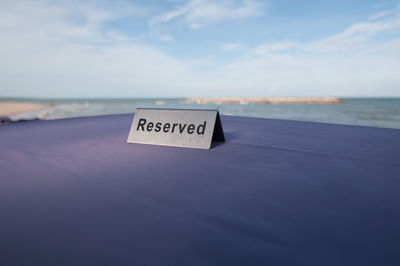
[0,115,400,266]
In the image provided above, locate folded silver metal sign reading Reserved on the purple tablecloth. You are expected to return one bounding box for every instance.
[127,108,225,149]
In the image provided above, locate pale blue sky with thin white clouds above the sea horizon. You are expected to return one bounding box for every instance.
[0,0,400,98]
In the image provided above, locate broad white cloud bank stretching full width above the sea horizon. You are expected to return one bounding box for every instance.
[0,1,400,97]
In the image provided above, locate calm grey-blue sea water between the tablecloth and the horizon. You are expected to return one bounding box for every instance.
[4,98,400,129]
